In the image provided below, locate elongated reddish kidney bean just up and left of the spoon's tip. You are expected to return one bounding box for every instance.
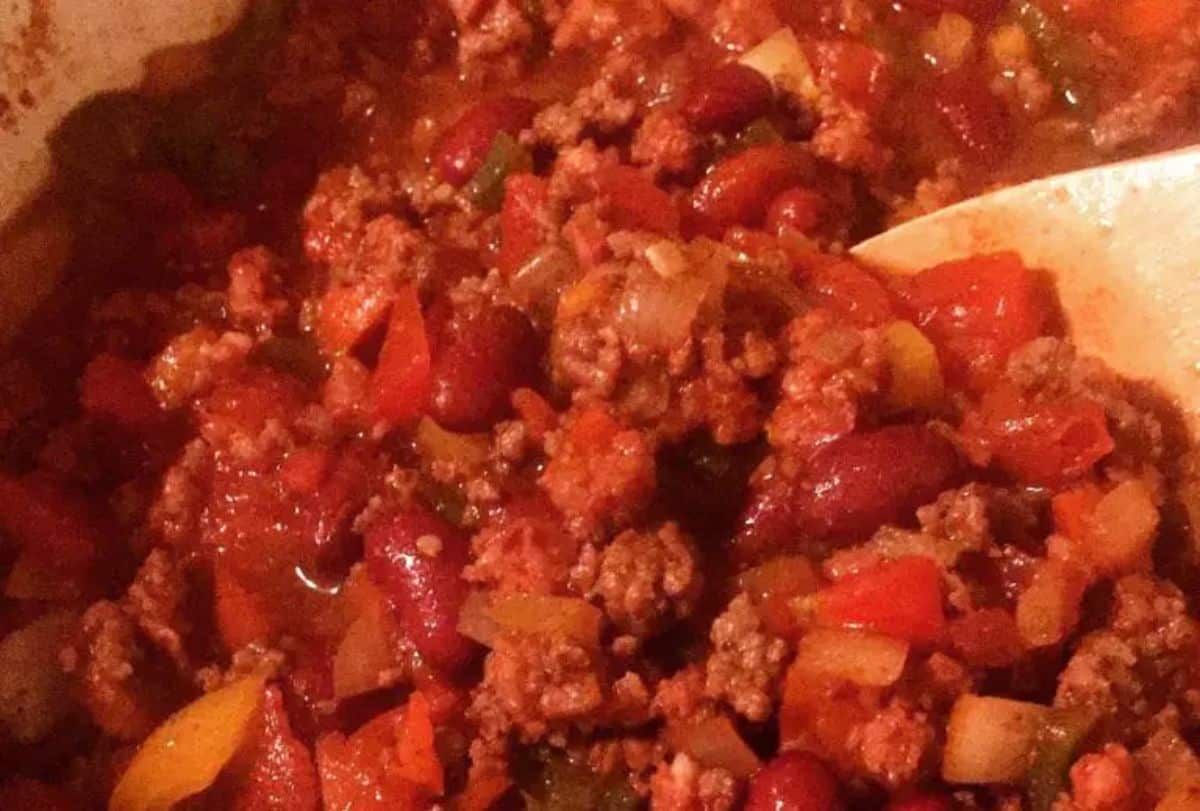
[689,144,814,239]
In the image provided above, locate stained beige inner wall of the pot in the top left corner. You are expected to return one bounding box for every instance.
[0,0,246,342]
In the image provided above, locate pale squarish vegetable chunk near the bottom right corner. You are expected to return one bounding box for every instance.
[942,693,1049,783]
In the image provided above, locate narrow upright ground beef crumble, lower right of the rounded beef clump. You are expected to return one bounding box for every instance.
[704,594,787,721]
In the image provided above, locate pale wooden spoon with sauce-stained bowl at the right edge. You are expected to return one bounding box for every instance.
[852,148,1200,437]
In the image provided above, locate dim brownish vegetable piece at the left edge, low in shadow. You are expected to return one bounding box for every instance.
[0,612,78,744]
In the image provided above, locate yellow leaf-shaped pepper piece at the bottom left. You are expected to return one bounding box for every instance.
[108,675,264,811]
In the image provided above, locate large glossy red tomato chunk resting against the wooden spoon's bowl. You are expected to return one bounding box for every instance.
[898,253,1049,389]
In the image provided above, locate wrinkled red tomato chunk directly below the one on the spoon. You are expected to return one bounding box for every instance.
[961,385,1114,486]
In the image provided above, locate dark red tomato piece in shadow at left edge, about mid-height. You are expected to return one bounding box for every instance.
[0,473,101,572]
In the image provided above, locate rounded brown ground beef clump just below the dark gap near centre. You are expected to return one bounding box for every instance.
[592,522,702,637]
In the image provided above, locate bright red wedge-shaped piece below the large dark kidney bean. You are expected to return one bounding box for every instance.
[816,557,946,645]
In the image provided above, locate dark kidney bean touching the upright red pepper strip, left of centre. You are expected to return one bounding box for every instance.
[430,307,541,431]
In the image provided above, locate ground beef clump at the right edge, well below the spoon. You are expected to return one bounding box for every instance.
[1055,575,1200,740]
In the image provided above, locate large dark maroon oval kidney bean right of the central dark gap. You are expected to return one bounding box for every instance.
[796,425,959,540]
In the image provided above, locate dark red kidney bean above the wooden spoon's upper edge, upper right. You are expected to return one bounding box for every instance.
[934,71,1015,164]
